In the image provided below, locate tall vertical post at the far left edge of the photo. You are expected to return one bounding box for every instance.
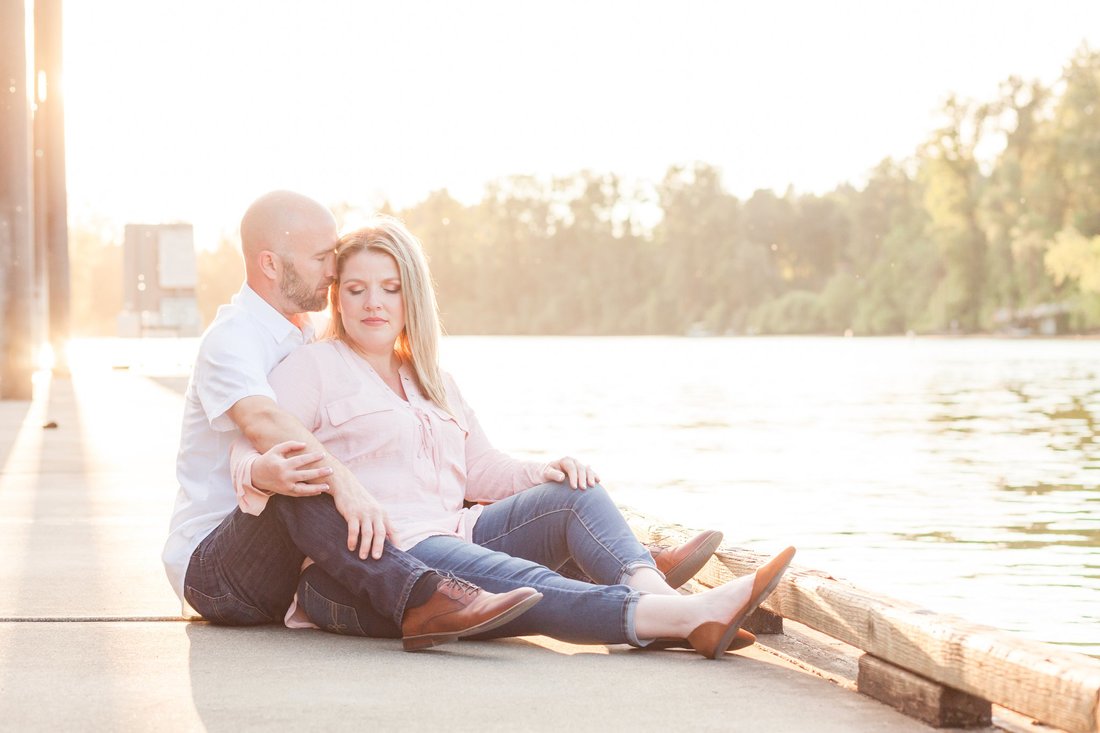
[0,0,34,400]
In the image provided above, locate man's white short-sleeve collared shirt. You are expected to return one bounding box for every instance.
[163,284,312,603]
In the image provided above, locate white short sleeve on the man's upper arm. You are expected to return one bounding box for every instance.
[194,316,275,433]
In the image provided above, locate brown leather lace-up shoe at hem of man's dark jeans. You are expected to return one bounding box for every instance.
[402,577,542,652]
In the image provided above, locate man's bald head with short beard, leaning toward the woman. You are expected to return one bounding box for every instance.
[241,190,338,317]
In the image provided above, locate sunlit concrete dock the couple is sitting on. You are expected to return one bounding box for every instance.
[0,364,991,733]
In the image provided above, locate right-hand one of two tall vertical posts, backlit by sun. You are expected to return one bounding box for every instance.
[34,0,72,372]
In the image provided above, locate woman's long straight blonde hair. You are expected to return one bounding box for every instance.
[328,215,451,412]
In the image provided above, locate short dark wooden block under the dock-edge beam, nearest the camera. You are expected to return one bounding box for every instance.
[857,654,993,727]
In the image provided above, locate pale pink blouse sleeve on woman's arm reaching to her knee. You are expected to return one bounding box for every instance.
[448,378,548,502]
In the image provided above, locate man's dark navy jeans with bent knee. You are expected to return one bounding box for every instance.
[184,494,429,636]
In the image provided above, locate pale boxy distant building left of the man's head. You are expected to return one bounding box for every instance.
[119,223,201,337]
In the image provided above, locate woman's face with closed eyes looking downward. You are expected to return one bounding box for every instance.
[339,250,405,355]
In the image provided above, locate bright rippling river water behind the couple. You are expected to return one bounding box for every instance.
[75,337,1100,656]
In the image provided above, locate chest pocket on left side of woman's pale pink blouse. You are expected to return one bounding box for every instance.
[319,394,408,464]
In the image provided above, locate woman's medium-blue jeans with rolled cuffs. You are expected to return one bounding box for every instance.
[298,483,653,645]
